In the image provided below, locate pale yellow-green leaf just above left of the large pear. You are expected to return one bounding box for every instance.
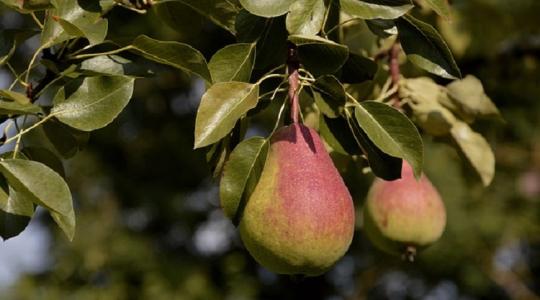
[195,81,259,149]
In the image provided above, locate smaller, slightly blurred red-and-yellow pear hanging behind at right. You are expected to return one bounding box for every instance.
[364,161,446,261]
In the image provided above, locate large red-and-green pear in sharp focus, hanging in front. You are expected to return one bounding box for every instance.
[239,123,354,276]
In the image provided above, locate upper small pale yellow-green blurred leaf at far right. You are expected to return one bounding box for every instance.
[446,75,500,119]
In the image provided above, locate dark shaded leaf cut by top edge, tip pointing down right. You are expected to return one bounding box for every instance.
[167,0,240,34]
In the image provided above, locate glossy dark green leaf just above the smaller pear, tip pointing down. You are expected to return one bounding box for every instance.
[355,101,424,178]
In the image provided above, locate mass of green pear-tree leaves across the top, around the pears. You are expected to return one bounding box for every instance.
[0,0,536,297]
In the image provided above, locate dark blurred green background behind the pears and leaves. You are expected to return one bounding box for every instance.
[0,0,540,300]
